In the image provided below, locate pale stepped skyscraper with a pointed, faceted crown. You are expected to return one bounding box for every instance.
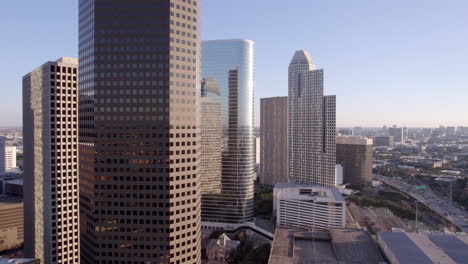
[288,50,336,187]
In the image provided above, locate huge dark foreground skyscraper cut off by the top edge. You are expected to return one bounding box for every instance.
[79,0,201,264]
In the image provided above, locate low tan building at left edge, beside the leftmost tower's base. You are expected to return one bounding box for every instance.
[0,198,24,251]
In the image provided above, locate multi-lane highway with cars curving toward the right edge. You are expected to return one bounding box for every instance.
[374,175,468,233]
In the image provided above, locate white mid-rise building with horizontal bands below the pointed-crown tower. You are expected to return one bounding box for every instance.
[273,183,346,230]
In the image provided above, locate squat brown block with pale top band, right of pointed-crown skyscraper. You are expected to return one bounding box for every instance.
[336,137,372,186]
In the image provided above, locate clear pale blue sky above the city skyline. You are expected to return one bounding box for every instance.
[0,0,468,127]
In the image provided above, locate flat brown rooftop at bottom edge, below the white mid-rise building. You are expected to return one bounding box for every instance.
[268,227,385,264]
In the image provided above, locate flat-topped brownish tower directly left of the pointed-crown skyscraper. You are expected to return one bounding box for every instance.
[260,96,288,185]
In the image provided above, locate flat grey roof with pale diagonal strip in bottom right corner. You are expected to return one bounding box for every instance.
[377,232,468,264]
